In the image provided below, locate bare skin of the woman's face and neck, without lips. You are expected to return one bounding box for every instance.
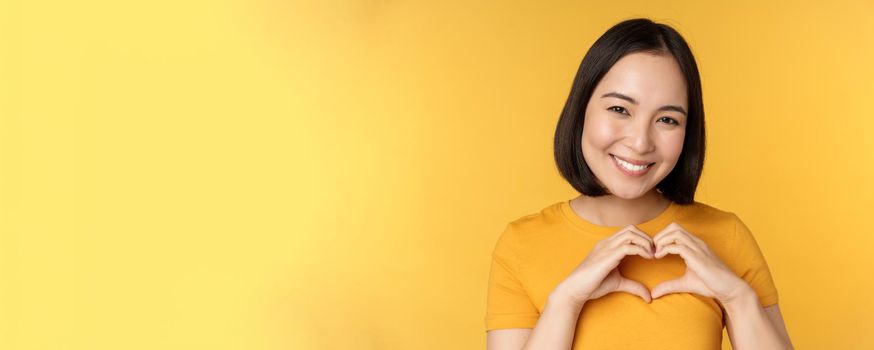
[571,53,688,227]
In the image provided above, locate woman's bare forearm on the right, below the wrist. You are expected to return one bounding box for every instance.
[724,288,795,350]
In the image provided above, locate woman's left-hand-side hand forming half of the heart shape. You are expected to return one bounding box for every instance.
[556,225,654,305]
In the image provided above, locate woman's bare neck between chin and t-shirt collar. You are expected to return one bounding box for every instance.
[571,189,671,227]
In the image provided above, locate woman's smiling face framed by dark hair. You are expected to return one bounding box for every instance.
[582,52,689,199]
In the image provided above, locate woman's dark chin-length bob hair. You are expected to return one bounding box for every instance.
[554,18,704,205]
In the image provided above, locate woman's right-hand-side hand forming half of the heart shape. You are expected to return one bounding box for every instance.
[651,222,749,305]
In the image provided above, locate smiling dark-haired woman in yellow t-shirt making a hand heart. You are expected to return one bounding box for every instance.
[485,19,792,350]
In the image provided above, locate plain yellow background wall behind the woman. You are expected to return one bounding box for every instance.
[0,0,874,349]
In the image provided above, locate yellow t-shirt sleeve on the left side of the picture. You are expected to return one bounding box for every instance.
[485,223,540,331]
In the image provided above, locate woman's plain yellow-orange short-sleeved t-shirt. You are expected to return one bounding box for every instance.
[485,201,777,349]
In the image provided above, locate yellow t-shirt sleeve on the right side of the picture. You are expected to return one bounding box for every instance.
[733,215,777,307]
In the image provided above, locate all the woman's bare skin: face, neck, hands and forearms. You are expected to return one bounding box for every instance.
[487,53,793,350]
